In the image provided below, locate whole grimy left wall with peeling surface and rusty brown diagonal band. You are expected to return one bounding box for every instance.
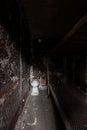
[0,26,29,130]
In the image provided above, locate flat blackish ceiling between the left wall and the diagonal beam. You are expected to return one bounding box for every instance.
[22,0,87,39]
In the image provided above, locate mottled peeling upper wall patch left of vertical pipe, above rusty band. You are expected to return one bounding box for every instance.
[0,26,19,89]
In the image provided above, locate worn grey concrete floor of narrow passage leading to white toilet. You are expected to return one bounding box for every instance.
[14,91,62,130]
